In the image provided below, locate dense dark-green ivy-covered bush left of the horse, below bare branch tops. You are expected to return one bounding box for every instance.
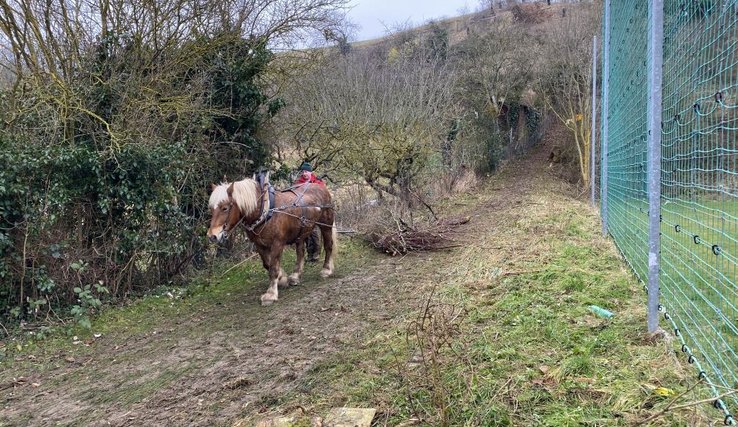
[0,34,276,324]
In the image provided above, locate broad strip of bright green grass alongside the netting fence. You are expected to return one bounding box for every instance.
[240,177,719,426]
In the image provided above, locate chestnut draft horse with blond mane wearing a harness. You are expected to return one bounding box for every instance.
[207,174,337,305]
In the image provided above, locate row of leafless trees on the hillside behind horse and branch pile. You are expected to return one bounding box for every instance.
[274,16,540,202]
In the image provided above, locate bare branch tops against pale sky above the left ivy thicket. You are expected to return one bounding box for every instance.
[0,0,347,76]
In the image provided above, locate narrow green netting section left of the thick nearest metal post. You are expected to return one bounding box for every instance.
[607,0,648,286]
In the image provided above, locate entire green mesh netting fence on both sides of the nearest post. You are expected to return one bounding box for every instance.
[602,0,738,423]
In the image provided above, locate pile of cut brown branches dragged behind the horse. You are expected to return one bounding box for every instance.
[366,216,470,256]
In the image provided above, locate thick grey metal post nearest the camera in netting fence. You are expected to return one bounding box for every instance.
[647,0,664,332]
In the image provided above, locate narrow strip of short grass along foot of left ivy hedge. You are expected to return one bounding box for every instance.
[0,238,379,381]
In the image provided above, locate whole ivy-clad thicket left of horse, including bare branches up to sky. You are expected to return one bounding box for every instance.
[0,0,346,317]
